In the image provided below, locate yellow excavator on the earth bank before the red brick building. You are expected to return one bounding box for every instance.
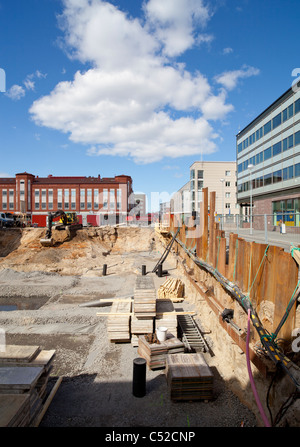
[40,210,82,247]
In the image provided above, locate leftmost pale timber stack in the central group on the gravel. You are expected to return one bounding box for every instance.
[107,300,131,343]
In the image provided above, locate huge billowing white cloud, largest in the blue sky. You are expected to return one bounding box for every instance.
[30,0,254,163]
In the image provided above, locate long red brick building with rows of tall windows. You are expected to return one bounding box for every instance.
[0,172,133,226]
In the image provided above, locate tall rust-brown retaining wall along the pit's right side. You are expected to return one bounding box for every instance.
[170,188,298,341]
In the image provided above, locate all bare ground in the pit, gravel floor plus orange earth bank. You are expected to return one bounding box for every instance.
[0,227,256,428]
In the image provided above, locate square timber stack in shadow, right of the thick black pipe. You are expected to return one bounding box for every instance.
[165,353,213,401]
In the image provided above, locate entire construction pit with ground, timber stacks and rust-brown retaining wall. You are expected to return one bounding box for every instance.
[0,188,300,429]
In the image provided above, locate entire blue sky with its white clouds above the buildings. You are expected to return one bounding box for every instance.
[0,0,300,211]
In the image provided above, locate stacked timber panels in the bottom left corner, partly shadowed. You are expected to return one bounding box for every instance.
[0,345,55,427]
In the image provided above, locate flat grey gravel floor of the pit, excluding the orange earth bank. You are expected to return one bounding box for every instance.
[0,270,256,427]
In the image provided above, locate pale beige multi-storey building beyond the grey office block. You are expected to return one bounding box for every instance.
[190,161,239,215]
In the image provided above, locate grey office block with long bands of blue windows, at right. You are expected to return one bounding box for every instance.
[236,87,300,229]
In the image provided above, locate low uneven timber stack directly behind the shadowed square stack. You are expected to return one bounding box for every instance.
[137,334,184,369]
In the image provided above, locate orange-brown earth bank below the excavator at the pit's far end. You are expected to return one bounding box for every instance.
[0,226,155,276]
